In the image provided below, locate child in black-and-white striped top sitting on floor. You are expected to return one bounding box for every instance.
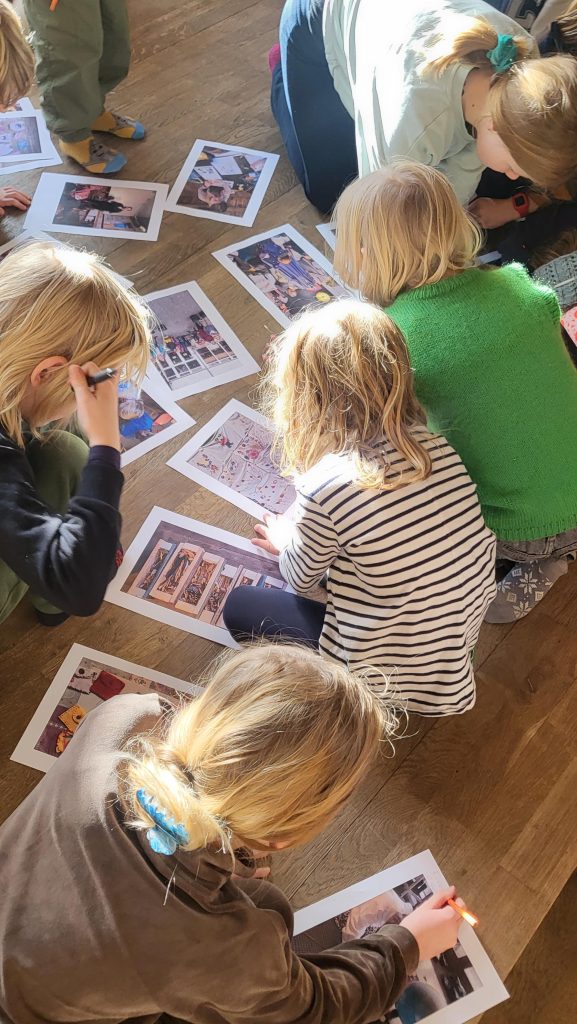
[224,300,495,715]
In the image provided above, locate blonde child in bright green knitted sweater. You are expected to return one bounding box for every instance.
[335,162,577,622]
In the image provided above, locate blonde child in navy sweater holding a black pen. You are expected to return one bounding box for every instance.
[0,242,150,626]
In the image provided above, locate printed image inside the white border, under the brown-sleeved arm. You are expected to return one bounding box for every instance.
[292,874,483,1024]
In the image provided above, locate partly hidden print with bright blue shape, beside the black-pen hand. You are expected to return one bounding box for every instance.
[118,380,195,466]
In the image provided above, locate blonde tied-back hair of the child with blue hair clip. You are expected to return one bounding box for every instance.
[119,644,396,852]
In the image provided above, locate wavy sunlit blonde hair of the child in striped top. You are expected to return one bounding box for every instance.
[261,299,431,490]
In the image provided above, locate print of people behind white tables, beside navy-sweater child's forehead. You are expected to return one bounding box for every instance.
[145,281,260,398]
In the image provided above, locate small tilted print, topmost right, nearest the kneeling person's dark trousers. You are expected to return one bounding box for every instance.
[166,139,279,226]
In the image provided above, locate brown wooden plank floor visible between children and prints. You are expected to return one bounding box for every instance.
[0,0,577,1024]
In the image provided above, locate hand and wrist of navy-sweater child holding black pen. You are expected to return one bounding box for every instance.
[69,362,120,452]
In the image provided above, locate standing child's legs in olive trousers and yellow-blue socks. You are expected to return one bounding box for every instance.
[24,0,145,174]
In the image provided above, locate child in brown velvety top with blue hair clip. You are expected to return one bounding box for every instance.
[0,645,460,1024]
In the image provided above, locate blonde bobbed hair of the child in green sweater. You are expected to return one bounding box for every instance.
[334,161,483,306]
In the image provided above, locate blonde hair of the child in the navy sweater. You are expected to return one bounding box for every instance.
[0,242,151,445]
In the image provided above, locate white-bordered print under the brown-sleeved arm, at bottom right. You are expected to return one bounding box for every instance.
[292,850,508,1024]
